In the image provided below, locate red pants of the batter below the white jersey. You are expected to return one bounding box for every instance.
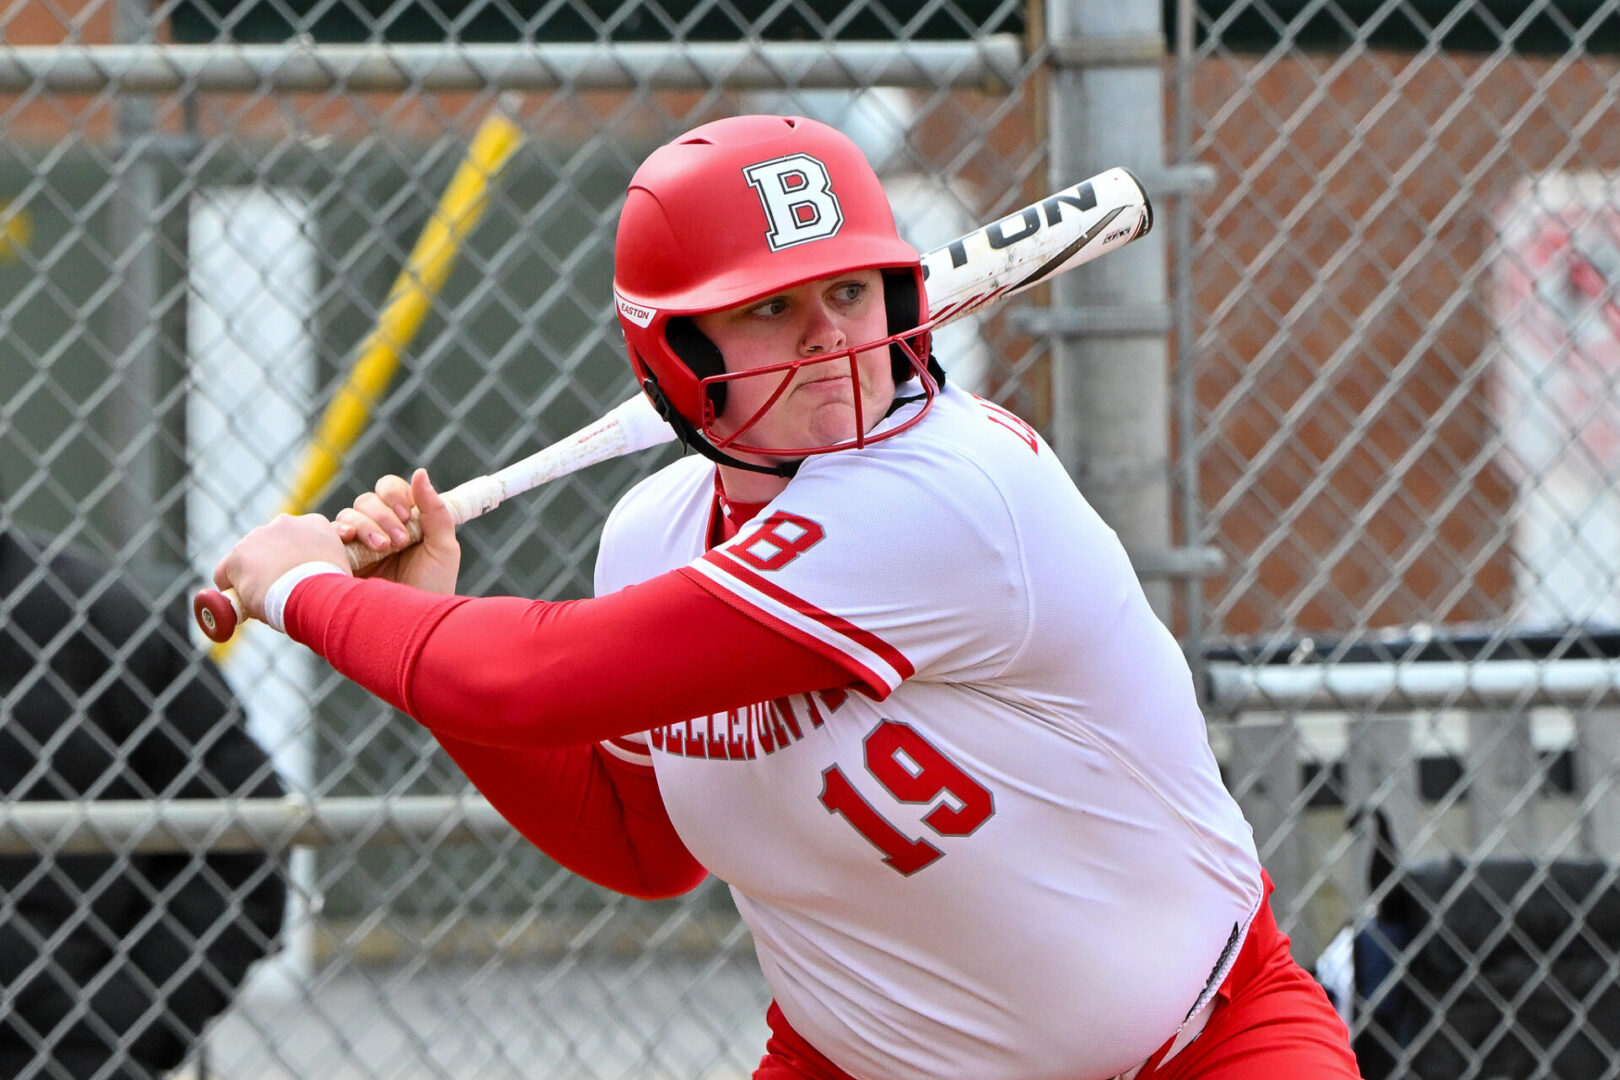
[753,878,1361,1080]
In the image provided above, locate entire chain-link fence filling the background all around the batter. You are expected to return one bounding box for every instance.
[0,0,1620,1080]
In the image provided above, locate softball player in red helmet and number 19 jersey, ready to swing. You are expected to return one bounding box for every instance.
[215,117,1356,1080]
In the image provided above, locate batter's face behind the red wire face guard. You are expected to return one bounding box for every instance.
[697,270,894,463]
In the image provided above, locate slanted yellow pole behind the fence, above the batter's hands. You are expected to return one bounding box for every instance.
[212,107,523,661]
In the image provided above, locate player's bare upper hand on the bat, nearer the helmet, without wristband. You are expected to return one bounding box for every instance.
[335,470,462,594]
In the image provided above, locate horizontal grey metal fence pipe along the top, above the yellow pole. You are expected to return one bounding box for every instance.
[0,34,1024,94]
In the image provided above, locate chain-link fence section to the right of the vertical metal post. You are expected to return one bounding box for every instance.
[1178,0,1620,1077]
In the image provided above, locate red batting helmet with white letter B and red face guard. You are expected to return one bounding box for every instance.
[614,117,940,474]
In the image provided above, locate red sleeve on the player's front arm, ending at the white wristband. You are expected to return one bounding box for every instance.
[287,570,857,746]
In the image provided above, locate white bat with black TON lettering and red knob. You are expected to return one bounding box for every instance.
[191,168,1153,641]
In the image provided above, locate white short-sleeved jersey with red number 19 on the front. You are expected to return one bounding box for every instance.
[596,389,1260,1080]
